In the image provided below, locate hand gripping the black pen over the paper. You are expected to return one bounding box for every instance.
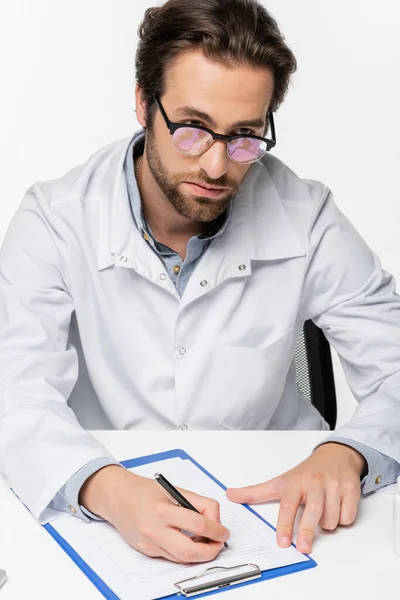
[79,465,230,563]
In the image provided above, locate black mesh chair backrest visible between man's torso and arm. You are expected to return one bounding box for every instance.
[295,321,337,429]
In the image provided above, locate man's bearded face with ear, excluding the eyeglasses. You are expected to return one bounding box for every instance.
[136,50,273,222]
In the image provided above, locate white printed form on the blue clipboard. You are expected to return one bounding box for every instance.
[52,458,308,600]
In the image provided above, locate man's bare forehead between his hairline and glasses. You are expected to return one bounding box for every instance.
[165,50,274,122]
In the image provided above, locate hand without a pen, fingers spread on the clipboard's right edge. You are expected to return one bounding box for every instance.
[227,442,366,553]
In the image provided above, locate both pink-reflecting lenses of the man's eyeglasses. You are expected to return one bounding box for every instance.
[172,127,267,163]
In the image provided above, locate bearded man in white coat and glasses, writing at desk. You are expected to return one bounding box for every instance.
[0,0,400,562]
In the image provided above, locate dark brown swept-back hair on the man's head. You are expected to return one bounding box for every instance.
[135,0,297,129]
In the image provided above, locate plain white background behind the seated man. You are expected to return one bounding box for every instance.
[0,0,400,424]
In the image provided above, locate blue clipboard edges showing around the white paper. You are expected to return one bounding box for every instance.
[43,448,317,600]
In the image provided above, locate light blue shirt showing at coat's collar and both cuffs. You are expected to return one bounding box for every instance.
[50,135,400,521]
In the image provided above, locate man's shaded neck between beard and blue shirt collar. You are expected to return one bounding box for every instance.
[135,156,210,256]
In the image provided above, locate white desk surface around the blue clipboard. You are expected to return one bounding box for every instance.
[0,431,400,600]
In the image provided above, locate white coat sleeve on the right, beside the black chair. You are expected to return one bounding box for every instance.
[301,190,400,462]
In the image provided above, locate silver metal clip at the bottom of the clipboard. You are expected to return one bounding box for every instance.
[174,563,261,598]
